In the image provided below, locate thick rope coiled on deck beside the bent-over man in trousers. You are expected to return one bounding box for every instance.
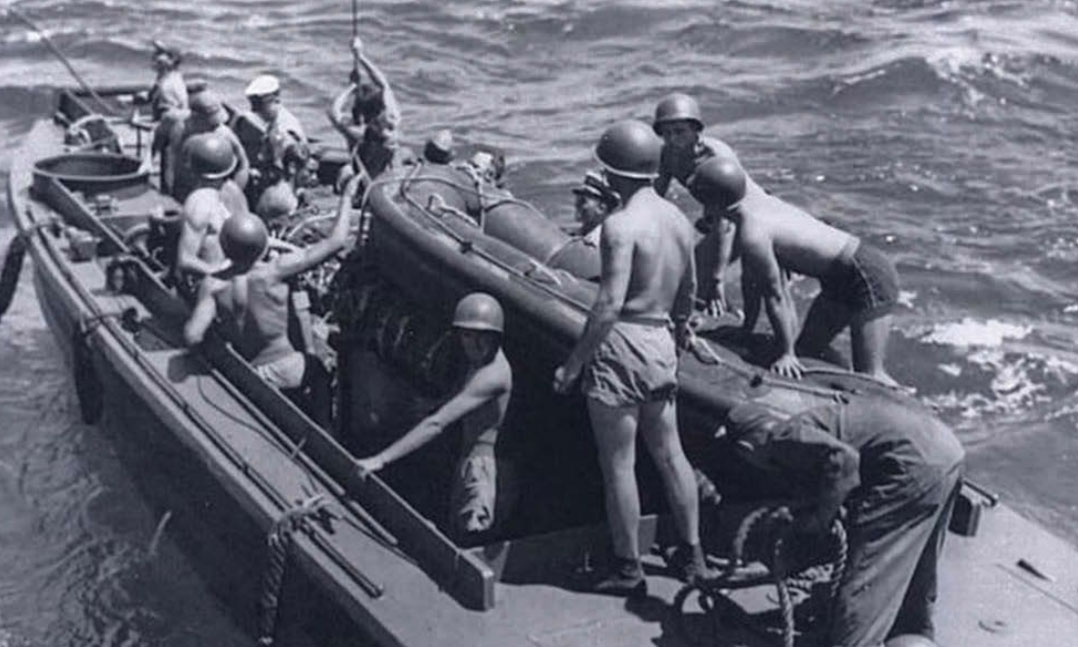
[674,506,848,647]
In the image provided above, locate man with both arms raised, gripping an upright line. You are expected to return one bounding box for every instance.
[327,37,401,178]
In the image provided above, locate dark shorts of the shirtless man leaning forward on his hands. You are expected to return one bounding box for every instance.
[819,242,898,320]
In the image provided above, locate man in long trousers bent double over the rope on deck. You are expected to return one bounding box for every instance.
[727,400,964,647]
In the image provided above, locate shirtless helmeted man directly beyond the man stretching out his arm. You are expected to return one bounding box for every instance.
[176,133,246,279]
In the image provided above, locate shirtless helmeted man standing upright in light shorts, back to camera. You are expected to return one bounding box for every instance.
[554,120,706,595]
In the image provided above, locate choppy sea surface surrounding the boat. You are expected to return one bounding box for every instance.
[0,0,1078,646]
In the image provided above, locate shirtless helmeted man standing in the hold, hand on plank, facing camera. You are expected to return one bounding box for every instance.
[356,292,513,537]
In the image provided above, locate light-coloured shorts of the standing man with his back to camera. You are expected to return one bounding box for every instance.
[581,320,677,407]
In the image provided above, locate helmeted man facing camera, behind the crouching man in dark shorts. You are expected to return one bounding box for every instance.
[652,93,759,316]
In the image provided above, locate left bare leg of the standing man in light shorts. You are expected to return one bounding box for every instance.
[588,398,640,560]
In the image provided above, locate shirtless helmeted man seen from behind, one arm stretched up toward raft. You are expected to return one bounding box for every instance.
[183,171,359,424]
